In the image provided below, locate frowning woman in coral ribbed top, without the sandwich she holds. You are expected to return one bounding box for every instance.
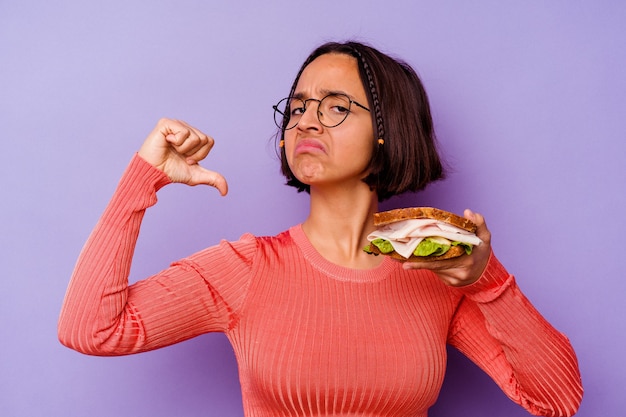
[59,42,582,417]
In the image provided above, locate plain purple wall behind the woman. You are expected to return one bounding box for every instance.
[0,0,626,417]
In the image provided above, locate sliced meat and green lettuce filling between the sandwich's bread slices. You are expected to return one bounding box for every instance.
[365,219,482,259]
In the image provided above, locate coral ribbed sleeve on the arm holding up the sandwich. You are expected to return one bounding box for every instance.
[449,250,583,416]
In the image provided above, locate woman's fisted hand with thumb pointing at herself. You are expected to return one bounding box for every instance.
[139,119,228,195]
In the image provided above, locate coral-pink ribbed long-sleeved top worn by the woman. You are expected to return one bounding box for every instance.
[59,157,582,417]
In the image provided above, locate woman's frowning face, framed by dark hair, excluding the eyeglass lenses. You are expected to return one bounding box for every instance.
[285,54,374,188]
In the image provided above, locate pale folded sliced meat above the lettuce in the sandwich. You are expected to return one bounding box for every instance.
[367,219,482,258]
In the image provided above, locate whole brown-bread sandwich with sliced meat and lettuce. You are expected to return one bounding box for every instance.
[363,207,482,262]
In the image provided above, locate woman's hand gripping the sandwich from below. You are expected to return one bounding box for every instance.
[403,209,491,287]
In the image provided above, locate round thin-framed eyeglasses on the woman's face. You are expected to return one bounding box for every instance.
[273,94,370,130]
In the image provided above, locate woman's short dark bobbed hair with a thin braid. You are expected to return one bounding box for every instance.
[277,41,444,201]
